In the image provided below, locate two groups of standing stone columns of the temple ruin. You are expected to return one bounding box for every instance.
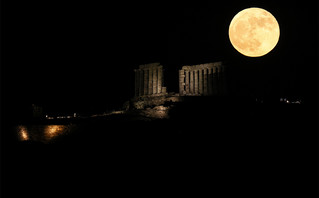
[134,62,226,97]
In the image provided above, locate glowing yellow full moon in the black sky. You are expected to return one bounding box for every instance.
[229,8,280,57]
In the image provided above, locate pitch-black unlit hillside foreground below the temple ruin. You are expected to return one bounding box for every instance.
[3,97,316,197]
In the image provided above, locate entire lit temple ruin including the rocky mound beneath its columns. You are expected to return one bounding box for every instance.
[129,62,226,118]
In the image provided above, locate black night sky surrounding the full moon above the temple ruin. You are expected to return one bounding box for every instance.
[1,0,318,116]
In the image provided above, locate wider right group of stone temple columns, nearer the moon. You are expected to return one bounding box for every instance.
[179,62,226,96]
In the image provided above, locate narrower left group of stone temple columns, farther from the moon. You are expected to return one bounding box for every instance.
[134,63,165,96]
